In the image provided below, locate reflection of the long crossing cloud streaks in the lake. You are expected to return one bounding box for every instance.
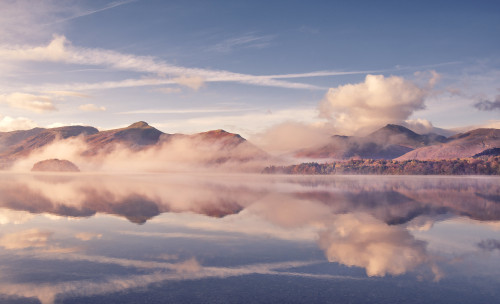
[0,252,340,304]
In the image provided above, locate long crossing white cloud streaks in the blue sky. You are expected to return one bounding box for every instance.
[0,35,366,90]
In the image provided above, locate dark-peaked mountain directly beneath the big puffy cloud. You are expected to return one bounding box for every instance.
[295,124,447,160]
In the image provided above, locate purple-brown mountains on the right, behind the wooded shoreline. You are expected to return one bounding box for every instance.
[294,124,500,160]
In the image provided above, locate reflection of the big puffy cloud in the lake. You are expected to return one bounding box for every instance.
[319,214,427,276]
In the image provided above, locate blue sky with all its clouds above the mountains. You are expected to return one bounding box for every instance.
[0,0,500,141]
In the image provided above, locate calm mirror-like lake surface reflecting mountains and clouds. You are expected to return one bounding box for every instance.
[0,174,500,304]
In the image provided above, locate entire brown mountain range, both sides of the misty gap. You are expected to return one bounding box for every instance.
[0,121,500,168]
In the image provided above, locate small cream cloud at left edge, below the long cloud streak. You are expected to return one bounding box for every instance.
[0,93,57,113]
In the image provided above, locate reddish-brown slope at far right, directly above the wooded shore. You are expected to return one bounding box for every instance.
[397,129,500,160]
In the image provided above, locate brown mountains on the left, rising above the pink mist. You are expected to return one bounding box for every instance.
[0,121,268,168]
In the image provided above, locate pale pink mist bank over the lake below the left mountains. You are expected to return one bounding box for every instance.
[10,136,278,172]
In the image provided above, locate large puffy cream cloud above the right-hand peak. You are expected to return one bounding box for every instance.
[319,74,437,133]
